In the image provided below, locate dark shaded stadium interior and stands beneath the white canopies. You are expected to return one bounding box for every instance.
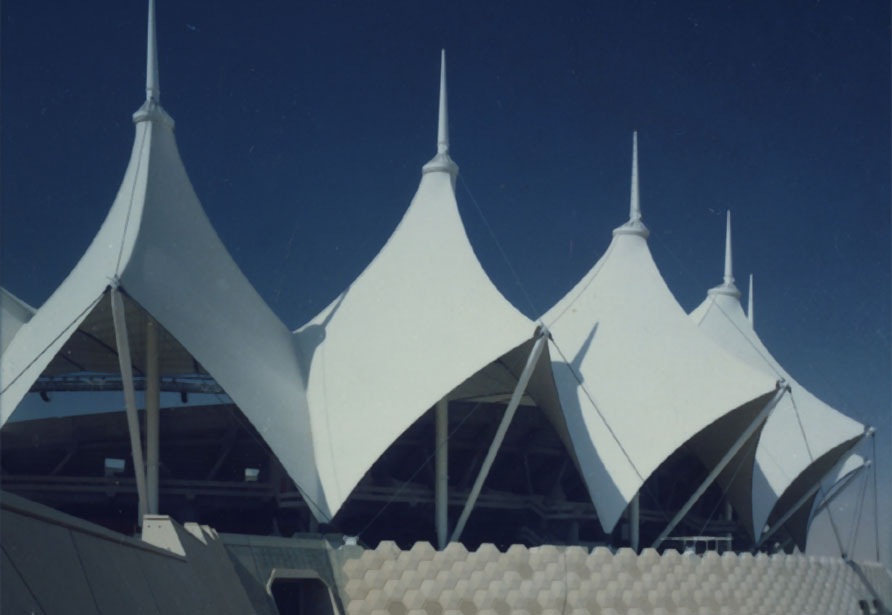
[0,304,776,551]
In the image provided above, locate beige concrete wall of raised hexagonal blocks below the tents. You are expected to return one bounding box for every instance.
[335,542,892,615]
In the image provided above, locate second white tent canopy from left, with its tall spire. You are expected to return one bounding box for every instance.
[295,54,536,511]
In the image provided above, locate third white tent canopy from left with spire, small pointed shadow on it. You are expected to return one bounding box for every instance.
[542,138,776,532]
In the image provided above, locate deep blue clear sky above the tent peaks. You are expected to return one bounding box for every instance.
[0,0,892,556]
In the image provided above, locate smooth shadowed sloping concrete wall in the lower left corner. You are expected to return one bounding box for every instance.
[0,492,254,615]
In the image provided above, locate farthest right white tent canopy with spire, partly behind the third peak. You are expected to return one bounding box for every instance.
[690,213,864,539]
